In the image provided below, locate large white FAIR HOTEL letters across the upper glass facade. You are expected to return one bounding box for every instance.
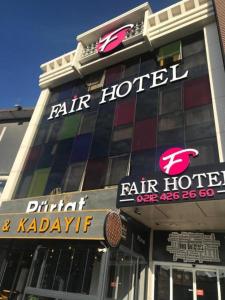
[48,64,188,120]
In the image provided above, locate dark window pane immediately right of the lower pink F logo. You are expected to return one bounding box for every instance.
[187,138,219,166]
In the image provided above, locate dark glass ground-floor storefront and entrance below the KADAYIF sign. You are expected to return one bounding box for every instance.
[0,227,225,300]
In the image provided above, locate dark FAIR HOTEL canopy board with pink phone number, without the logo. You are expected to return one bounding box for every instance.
[117,163,225,208]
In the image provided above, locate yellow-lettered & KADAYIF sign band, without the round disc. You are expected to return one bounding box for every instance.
[0,210,108,240]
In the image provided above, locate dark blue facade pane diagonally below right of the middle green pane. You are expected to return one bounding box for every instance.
[70,133,92,162]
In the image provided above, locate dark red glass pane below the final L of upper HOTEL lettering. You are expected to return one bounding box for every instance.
[184,76,211,109]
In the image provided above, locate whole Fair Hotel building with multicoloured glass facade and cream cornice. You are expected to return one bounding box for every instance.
[0,0,225,300]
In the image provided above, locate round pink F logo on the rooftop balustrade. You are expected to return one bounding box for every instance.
[96,24,134,53]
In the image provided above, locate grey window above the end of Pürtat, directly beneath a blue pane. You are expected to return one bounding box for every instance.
[63,162,86,192]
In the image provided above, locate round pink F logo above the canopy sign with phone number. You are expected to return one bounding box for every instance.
[159,148,199,175]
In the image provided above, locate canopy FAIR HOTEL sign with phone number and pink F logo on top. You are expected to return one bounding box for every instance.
[117,148,225,208]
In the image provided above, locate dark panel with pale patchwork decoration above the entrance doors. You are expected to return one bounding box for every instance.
[153,231,225,265]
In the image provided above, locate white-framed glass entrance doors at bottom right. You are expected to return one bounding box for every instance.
[153,263,225,300]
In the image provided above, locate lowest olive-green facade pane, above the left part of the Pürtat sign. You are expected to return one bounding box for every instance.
[27,168,50,197]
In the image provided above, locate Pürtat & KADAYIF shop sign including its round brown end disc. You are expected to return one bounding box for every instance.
[0,194,122,247]
